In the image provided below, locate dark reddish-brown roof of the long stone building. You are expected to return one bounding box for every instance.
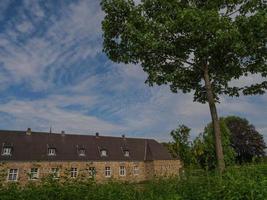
[0,131,173,161]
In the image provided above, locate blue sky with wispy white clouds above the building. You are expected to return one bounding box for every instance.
[0,0,267,141]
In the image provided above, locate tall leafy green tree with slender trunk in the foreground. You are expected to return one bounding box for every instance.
[101,0,266,171]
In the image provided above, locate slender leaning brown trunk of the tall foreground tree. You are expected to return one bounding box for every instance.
[204,66,225,172]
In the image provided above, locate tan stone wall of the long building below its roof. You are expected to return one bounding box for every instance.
[0,160,181,184]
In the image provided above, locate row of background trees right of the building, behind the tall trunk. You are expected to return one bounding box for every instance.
[164,116,266,169]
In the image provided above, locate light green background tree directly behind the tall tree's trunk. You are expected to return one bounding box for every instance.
[193,118,235,169]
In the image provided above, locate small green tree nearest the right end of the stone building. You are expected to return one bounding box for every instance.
[169,125,192,166]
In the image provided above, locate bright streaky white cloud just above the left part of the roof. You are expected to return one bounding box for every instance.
[0,96,124,134]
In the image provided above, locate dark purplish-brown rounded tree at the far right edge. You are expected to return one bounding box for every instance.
[224,116,266,163]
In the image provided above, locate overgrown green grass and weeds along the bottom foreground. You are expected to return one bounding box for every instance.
[0,164,267,200]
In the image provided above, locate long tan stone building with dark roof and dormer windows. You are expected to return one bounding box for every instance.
[0,129,181,183]
